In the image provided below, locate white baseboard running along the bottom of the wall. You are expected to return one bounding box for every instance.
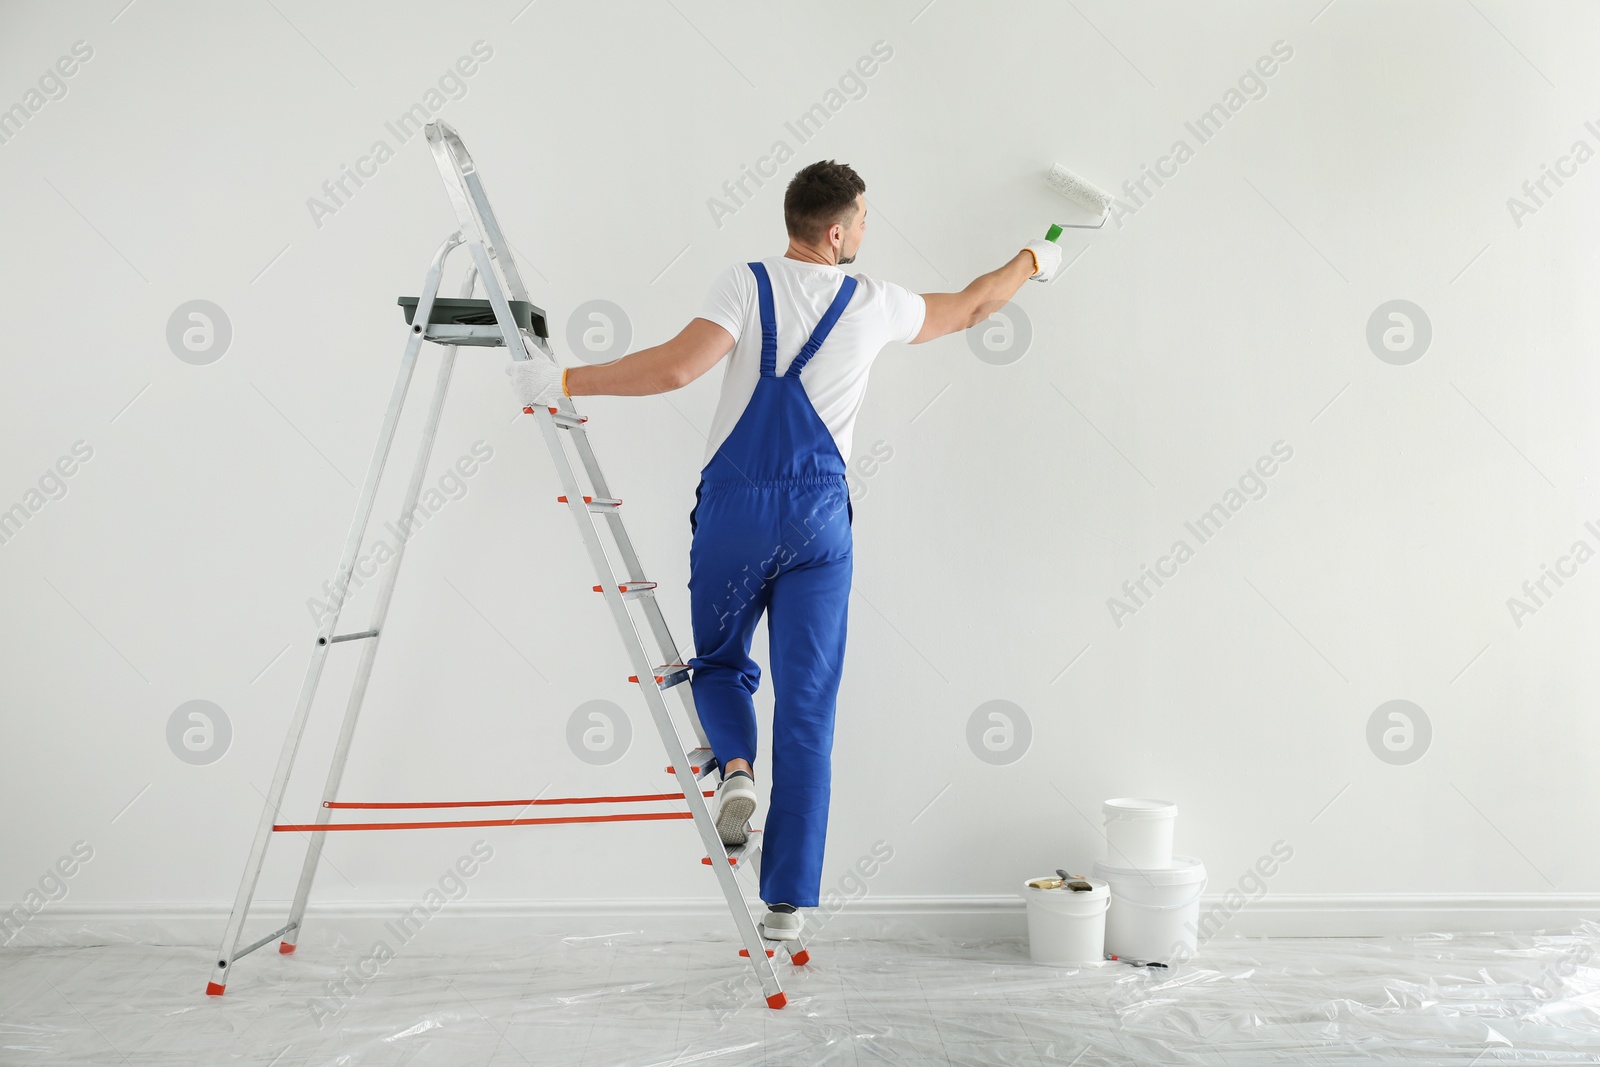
[0,893,1600,950]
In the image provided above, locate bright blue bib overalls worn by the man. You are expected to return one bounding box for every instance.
[690,262,856,907]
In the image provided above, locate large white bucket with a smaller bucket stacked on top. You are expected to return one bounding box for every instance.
[1094,856,1206,963]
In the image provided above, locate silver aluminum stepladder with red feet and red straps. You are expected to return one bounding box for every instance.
[206,122,810,1008]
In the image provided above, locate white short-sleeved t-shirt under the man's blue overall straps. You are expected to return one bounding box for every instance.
[699,256,928,466]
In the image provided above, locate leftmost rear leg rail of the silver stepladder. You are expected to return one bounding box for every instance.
[206,230,461,993]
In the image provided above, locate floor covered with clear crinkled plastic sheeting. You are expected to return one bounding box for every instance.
[0,923,1600,1067]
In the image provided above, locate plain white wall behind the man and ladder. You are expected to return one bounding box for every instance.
[0,0,1600,939]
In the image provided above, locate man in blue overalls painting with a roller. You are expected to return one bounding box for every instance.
[507,160,1061,941]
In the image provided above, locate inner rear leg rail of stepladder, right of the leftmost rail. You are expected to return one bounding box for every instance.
[280,266,478,952]
